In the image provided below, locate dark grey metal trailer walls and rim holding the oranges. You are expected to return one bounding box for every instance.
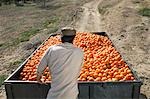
[4,32,142,99]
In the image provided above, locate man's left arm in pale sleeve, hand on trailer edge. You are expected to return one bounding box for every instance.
[37,49,50,83]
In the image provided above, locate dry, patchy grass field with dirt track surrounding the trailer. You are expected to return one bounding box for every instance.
[0,0,150,99]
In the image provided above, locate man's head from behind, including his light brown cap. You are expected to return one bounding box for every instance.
[61,27,76,43]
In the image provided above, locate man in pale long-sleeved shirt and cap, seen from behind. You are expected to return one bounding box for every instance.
[37,27,83,99]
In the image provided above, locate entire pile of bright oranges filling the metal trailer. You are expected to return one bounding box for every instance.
[20,33,135,81]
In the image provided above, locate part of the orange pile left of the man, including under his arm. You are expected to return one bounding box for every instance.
[20,36,61,81]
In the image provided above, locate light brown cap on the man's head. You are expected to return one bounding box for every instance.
[61,27,76,36]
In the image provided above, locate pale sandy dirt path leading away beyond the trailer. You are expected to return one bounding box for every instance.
[75,0,102,32]
